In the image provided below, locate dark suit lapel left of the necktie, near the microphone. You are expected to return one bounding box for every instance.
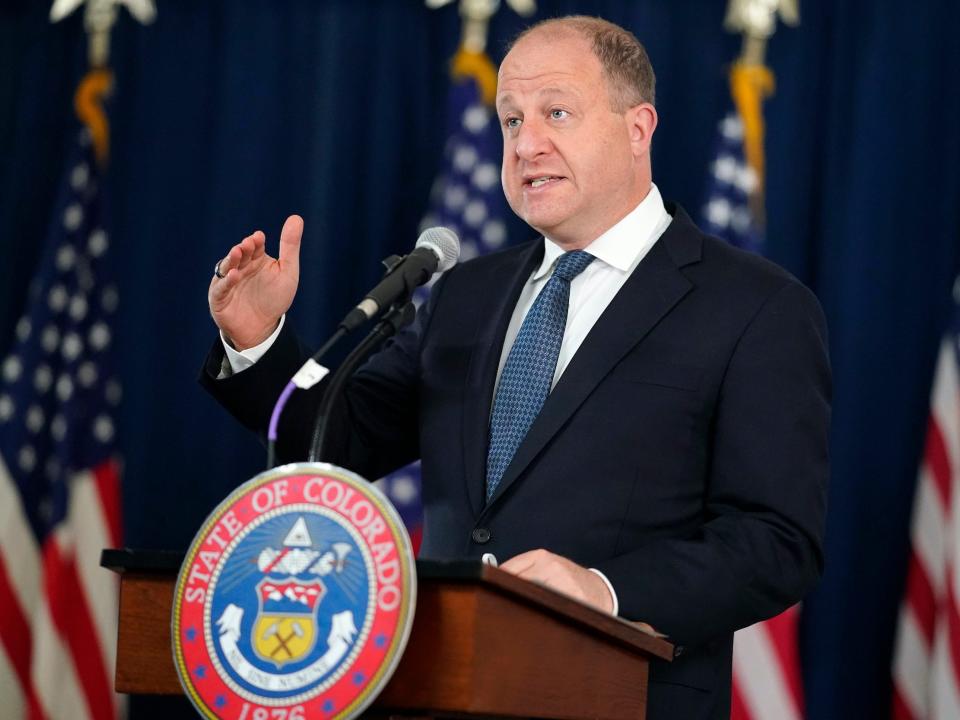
[463,238,543,517]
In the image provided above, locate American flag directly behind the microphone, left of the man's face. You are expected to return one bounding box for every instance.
[381,49,507,549]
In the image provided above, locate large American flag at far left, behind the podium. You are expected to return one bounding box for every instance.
[0,130,120,720]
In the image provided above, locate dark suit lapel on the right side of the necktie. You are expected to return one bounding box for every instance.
[488,208,700,507]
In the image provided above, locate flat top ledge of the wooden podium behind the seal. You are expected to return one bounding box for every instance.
[100,548,675,661]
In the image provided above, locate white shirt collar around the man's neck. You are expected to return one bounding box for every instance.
[531,183,667,280]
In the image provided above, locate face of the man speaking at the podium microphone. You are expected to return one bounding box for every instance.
[497,32,646,249]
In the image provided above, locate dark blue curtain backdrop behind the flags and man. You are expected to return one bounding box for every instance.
[0,0,960,719]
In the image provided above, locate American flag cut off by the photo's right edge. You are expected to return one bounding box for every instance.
[893,280,960,720]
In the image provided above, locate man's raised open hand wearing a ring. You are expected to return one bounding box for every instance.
[207,215,303,350]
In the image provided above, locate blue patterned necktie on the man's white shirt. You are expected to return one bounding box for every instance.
[487,250,594,502]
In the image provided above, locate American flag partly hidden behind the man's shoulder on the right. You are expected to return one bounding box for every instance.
[702,110,803,720]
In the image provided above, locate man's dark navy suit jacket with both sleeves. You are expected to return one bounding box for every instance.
[202,205,830,720]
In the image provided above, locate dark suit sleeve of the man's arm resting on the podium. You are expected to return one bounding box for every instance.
[596,282,831,644]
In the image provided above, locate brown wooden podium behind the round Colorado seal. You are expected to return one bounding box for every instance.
[101,550,673,720]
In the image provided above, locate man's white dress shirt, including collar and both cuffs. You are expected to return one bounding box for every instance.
[220,185,672,615]
